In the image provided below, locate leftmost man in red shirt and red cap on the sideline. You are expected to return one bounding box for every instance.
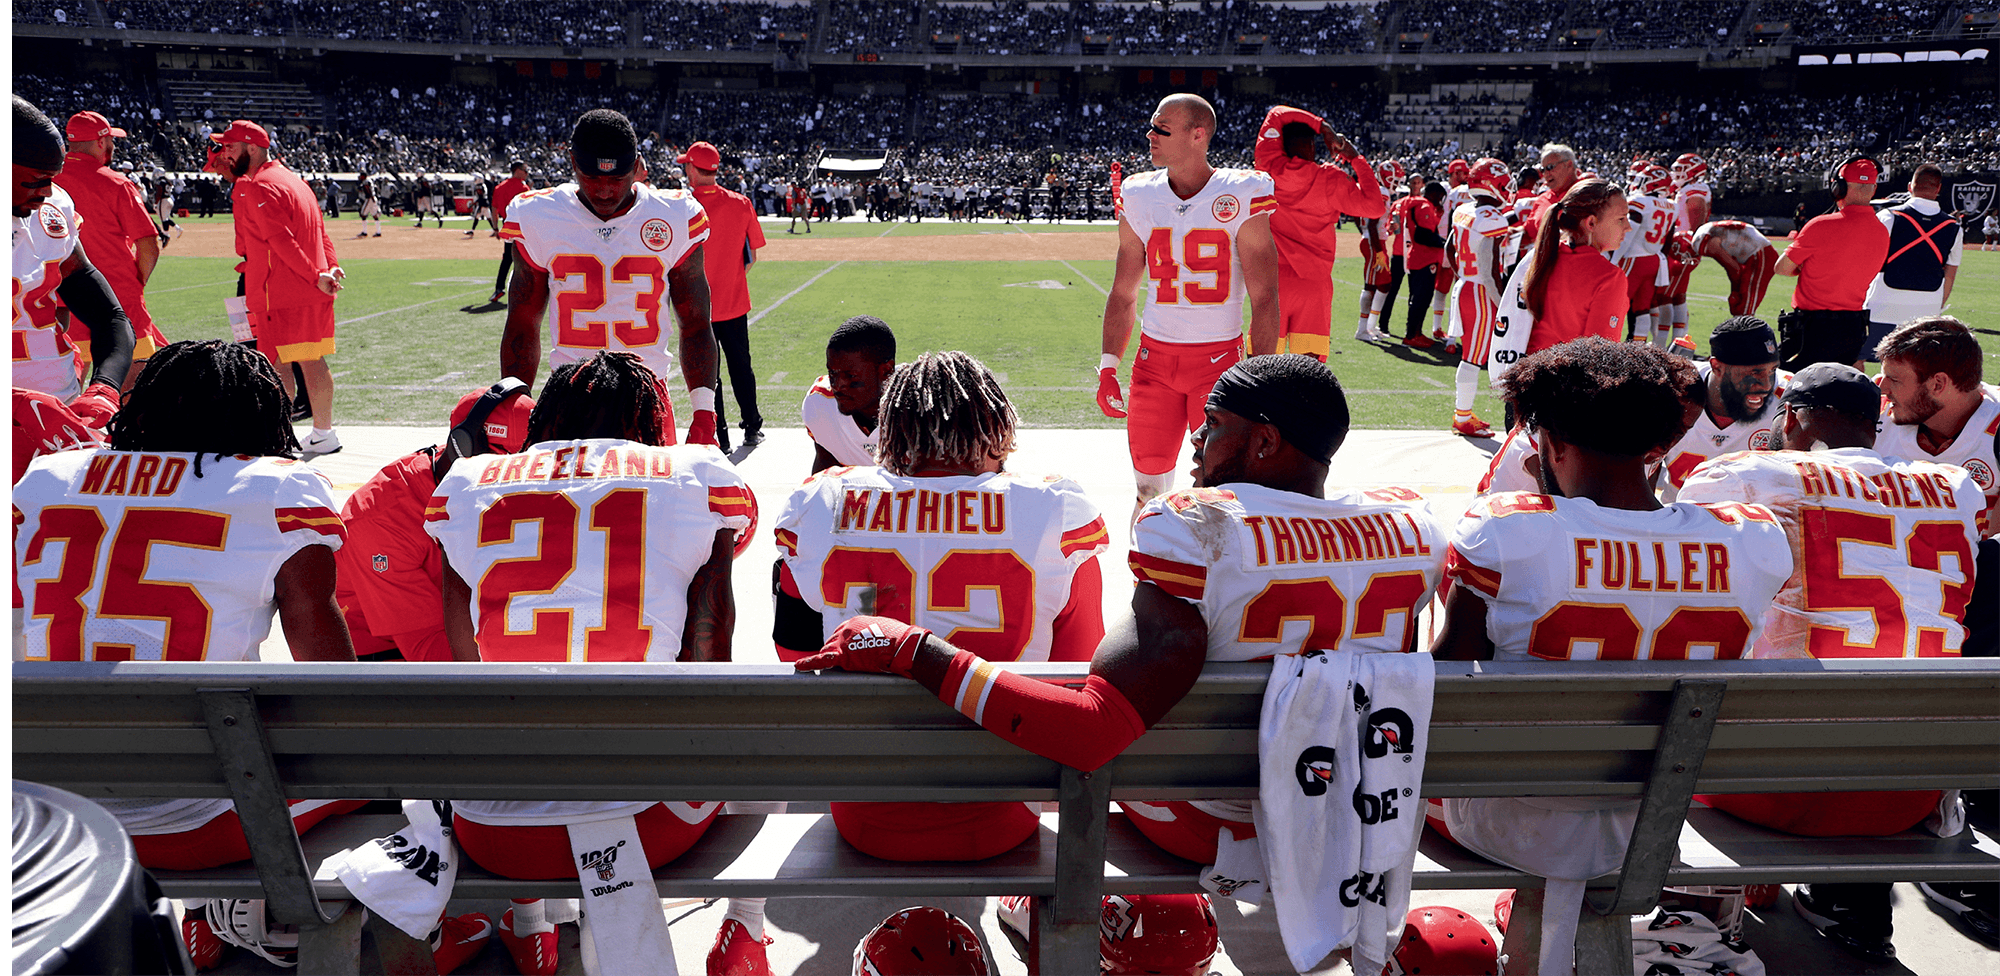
[56,112,166,390]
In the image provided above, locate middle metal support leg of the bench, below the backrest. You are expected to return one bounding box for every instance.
[1028,766,1112,974]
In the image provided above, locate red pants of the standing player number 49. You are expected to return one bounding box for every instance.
[1126,334,1244,474]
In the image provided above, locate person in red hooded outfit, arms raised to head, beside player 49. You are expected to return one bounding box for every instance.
[1256,106,1386,362]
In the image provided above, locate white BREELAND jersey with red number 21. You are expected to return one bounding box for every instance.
[424,438,756,662]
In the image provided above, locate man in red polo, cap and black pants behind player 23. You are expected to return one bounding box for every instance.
[674,142,764,454]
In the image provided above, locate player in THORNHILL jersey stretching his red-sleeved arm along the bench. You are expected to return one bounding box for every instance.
[798,354,1444,864]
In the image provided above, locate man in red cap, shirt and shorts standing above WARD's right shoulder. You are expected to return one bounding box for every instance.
[208,118,346,456]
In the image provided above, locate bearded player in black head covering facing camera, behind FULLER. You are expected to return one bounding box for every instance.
[1658,316,1792,502]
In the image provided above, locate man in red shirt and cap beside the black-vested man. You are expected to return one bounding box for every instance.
[1774,156,1888,372]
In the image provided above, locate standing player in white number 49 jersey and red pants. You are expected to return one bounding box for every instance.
[1098,94,1280,518]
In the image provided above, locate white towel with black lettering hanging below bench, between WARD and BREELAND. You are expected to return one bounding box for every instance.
[314,800,458,938]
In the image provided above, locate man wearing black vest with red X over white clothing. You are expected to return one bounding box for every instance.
[1864,162,1966,360]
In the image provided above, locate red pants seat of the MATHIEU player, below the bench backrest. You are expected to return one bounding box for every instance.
[828,804,1042,860]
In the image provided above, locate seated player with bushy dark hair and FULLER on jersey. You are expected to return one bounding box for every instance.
[1430,336,1792,972]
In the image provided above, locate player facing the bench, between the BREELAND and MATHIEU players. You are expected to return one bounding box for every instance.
[798,316,896,474]
